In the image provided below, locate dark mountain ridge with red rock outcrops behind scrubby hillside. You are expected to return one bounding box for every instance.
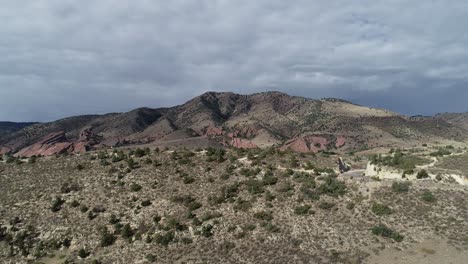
[0,92,468,156]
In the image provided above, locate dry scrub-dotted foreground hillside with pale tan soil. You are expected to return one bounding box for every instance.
[0,145,468,264]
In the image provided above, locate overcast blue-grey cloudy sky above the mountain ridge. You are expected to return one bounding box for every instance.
[0,0,468,121]
